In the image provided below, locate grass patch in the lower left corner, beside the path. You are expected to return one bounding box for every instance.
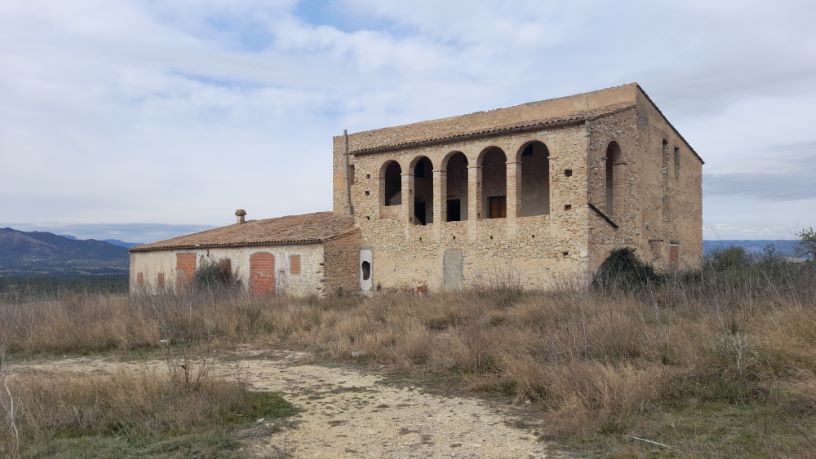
[0,370,293,457]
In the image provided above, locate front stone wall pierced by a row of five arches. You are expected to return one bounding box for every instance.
[340,123,588,290]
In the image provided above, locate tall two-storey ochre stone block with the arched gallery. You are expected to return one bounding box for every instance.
[334,84,703,290]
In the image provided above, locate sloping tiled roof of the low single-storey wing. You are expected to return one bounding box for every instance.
[130,212,355,252]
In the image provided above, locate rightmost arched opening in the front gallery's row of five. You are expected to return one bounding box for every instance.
[516,140,550,217]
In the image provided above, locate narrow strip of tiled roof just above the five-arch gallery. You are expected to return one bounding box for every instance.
[349,102,635,155]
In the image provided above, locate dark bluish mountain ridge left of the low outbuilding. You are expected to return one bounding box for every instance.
[0,228,129,276]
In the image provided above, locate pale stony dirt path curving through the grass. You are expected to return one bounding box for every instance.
[9,350,564,459]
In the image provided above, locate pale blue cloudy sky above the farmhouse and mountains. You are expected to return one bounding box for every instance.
[0,0,816,242]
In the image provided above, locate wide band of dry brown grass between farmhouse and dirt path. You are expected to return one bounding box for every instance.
[0,253,816,458]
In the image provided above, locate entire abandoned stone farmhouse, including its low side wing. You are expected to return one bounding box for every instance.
[130,83,703,295]
